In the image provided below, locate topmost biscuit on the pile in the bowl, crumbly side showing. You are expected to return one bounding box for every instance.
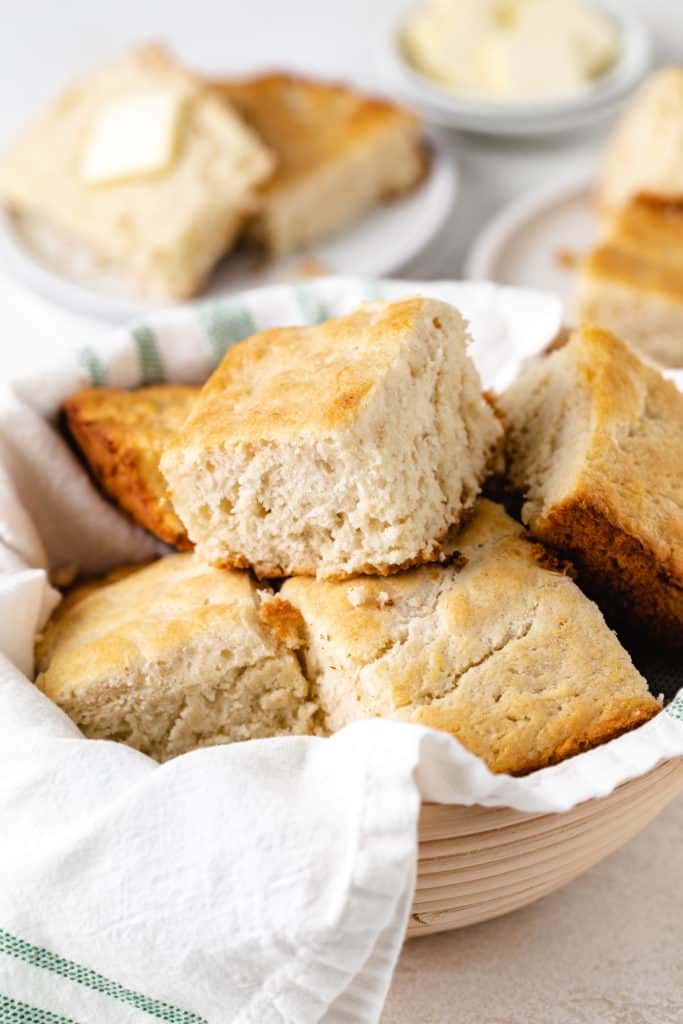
[161,297,501,578]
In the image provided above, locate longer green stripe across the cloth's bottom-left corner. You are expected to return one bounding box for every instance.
[0,929,207,1024]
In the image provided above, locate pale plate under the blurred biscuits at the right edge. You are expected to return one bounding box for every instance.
[465,166,597,305]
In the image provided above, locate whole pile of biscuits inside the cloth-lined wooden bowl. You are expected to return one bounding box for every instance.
[36,297,683,774]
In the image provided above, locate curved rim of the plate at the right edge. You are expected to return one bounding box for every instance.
[463,162,597,284]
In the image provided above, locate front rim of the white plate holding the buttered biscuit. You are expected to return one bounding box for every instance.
[0,131,460,323]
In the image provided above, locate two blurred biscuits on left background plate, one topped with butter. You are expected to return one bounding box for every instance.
[0,46,427,299]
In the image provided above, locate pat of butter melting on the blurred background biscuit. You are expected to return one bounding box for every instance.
[81,89,189,185]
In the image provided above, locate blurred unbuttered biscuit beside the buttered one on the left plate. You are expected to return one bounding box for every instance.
[216,74,426,256]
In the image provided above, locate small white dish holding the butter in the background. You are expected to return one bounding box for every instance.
[382,0,652,135]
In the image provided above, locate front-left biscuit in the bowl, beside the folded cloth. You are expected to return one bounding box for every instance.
[36,554,315,761]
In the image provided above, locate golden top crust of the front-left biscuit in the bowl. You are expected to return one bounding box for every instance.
[36,554,276,699]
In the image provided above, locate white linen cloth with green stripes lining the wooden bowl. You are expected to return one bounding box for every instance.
[0,279,683,1024]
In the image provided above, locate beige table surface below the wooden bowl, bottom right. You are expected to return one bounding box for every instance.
[382,797,683,1024]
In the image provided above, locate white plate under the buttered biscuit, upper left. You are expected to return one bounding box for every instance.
[0,137,458,322]
